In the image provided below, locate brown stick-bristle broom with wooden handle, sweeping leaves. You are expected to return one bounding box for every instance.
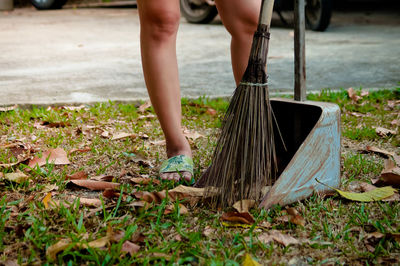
[196,0,277,207]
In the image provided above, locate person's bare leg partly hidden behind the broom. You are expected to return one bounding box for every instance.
[215,0,261,85]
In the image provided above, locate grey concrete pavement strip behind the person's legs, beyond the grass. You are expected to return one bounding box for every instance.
[0,8,400,105]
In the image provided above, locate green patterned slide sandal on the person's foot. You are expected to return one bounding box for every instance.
[160,155,194,185]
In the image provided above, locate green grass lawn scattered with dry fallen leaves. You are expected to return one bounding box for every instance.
[0,89,400,265]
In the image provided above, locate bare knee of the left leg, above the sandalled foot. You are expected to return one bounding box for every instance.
[141,12,180,42]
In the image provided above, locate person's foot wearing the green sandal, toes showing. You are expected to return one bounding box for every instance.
[160,139,193,183]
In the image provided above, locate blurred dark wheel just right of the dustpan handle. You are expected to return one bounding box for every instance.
[305,0,332,31]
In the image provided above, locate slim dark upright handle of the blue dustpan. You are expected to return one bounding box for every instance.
[294,0,306,101]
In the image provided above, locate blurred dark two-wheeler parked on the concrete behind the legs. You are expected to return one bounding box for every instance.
[179,0,332,31]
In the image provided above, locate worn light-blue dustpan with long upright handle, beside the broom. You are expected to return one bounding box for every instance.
[260,0,340,209]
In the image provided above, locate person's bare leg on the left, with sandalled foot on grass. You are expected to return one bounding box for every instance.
[137,0,192,180]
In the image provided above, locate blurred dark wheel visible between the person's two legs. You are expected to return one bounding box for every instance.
[179,0,218,24]
